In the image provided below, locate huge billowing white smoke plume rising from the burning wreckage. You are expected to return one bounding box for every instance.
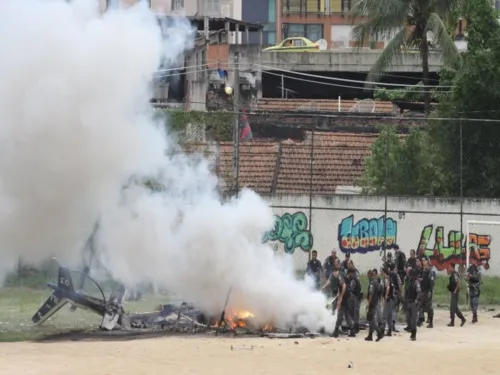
[0,0,333,329]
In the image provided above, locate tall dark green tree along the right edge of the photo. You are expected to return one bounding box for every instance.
[429,0,500,197]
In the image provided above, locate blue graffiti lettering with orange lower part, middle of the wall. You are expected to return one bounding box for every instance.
[338,215,398,254]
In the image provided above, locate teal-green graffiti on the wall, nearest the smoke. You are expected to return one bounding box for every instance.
[264,211,313,254]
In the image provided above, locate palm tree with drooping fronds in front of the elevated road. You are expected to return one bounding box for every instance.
[352,0,460,114]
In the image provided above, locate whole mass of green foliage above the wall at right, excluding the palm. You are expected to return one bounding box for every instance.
[363,0,500,197]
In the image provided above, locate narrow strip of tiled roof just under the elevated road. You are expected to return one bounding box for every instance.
[257,98,394,113]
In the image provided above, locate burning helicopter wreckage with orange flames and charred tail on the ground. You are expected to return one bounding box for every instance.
[32,266,326,338]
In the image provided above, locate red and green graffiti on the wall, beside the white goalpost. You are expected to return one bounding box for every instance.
[418,225,491,271]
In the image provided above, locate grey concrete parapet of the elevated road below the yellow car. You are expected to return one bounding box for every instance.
[262,49,441,73]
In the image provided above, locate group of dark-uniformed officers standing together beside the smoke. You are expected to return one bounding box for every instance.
[306,245,481,341]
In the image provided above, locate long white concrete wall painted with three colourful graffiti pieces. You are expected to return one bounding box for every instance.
[266,195,500,276]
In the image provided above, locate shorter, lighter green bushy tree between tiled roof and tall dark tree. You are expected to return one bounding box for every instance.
[361,126,444,195]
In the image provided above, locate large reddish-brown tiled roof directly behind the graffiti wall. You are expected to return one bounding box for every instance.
[186,132,378,194]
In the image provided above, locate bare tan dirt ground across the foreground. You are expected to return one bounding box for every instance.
[0,312,500,375]
